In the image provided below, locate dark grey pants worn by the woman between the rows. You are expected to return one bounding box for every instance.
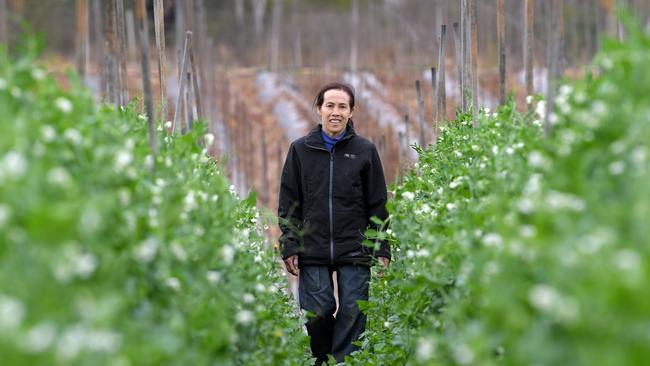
[298,265,370,365]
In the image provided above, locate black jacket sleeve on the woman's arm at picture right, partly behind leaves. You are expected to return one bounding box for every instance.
[363,145,391,258]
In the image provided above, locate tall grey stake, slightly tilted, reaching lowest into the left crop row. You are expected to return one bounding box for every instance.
[135,0,158,156]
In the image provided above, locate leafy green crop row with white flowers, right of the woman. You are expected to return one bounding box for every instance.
[348,19,650,365]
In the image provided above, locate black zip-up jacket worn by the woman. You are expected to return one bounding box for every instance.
[278,120,390,265]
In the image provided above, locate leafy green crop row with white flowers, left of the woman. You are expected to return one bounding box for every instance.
[0,39,308,365]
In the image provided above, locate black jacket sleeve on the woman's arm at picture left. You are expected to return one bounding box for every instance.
[278,144,302,259]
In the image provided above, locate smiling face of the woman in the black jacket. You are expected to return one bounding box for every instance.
[318,89,352,137]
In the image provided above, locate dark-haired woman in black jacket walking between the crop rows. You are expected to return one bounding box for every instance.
[278,83,390,364]
